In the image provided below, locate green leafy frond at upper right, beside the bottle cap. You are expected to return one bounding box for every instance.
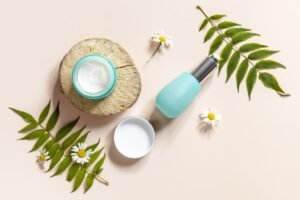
[196,6,289,99]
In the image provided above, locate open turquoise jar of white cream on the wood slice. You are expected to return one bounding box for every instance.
[72,54,116,99]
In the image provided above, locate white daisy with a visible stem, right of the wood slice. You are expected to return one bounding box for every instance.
[146,31,173,63]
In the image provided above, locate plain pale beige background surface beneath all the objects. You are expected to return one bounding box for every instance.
[0,0,300,200]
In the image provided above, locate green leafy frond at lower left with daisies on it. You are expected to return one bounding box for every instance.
[10,101,108,192]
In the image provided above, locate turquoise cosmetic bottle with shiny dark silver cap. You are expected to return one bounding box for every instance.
[156,55,218,118]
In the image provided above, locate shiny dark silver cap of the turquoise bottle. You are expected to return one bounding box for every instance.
[192,55,218,82]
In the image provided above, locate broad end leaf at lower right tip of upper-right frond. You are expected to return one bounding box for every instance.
[258,72,290,96]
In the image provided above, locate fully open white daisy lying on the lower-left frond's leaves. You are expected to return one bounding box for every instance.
[71,143,92,164]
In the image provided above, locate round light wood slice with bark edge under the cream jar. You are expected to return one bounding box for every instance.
[59,38,141,116]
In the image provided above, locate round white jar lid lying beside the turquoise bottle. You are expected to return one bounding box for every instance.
[114,116,155,158]
